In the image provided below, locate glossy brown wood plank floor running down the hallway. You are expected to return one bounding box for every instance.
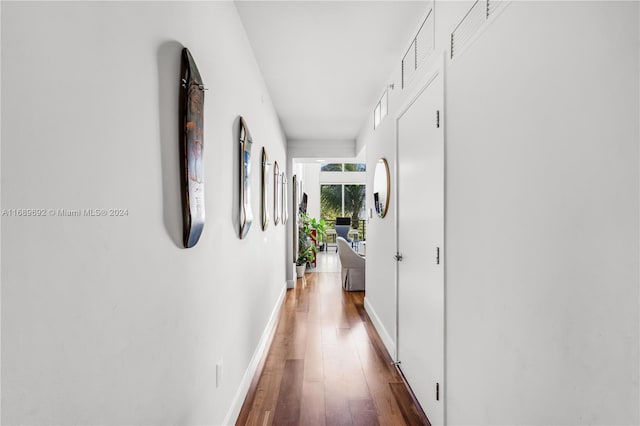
[236,272,429,426]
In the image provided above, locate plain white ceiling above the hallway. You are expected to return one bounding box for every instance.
[236,0,427,140]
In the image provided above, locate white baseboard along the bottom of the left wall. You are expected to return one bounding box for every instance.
[222,282,288,425]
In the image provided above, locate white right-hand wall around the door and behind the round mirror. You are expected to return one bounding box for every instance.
[358,2,640,425]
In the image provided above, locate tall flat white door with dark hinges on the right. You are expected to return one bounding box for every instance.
[396,72,445,425]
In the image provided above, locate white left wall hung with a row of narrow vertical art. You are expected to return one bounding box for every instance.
[1,2,286,425]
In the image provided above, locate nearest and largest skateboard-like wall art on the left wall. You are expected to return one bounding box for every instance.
[178,47,206,248]
